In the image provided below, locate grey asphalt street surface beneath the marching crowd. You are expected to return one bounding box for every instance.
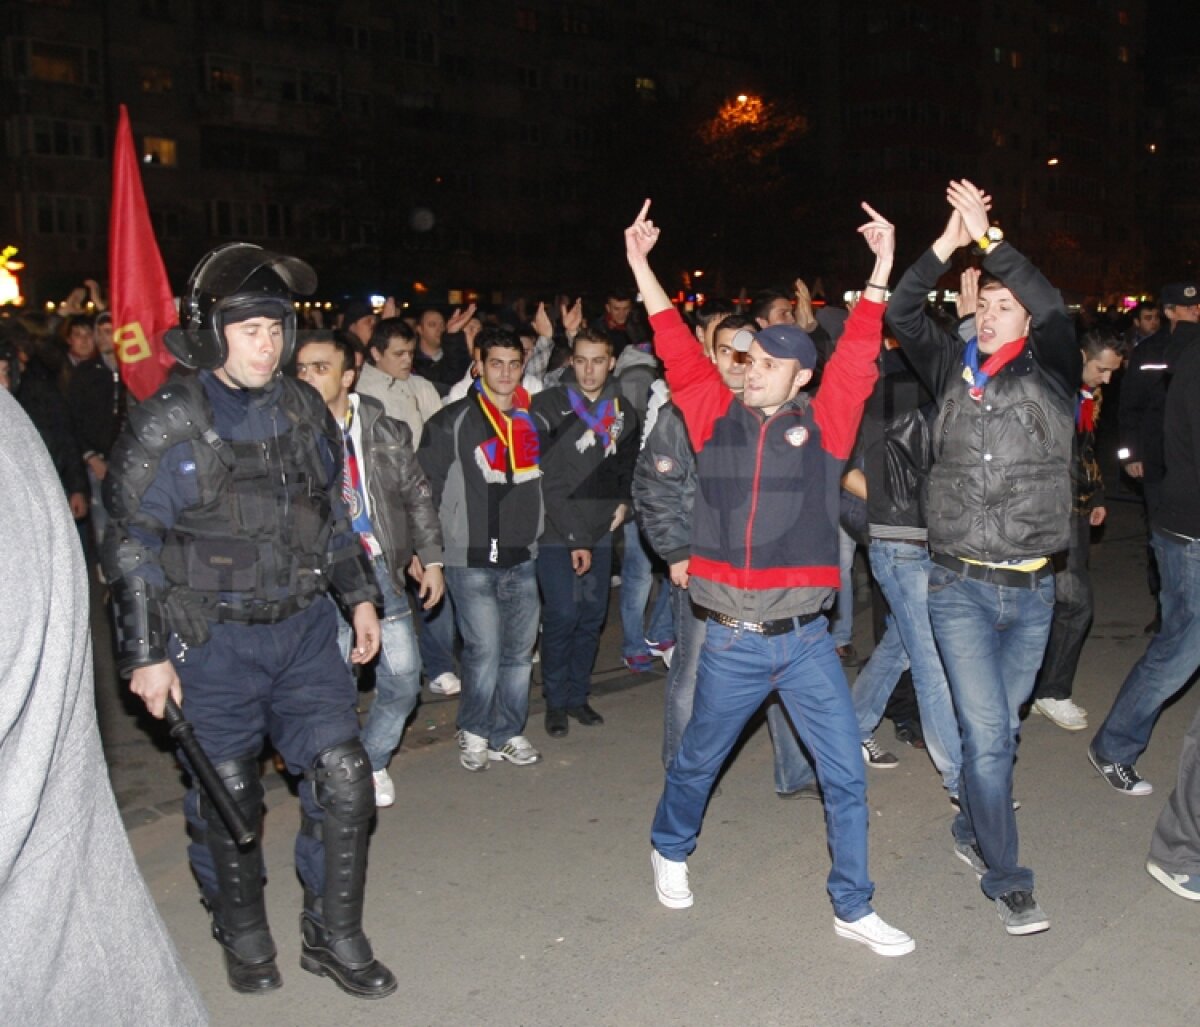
[95,502,1200,1027]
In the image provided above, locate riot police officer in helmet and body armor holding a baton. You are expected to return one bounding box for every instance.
[103,242,396,998]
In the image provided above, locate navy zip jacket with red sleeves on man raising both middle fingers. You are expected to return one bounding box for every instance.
[650,300,884,590]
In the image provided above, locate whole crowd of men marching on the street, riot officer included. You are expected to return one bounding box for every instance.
[7,181,1200,997]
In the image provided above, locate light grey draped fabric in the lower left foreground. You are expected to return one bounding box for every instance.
[0,389,208,1025]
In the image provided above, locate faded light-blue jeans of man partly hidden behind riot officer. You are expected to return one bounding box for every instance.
[337,557,421,770]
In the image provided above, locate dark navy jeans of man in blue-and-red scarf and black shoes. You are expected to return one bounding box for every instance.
[538,535,612,709]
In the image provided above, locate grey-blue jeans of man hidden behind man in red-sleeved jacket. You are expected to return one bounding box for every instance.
[662,585,814,792]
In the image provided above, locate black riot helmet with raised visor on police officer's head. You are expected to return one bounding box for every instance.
[163,242,317,371]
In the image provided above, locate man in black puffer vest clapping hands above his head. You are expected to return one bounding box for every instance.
[888,181,1082,935]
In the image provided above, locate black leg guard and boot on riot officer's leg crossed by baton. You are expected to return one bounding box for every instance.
[192,758,283,992]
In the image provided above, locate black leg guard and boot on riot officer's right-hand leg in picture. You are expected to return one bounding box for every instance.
[300,739,396,998]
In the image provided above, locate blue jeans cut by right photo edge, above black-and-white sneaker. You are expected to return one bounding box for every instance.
[1092,531,1200,763]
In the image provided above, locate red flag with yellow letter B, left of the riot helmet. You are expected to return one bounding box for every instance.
[108,103,179,400]
